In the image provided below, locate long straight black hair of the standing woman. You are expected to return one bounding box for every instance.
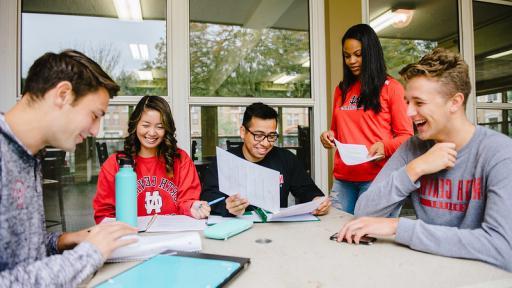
[339,24,388,113]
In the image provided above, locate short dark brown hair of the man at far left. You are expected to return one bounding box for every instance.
[22,50,120,101]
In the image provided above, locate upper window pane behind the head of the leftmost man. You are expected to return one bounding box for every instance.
[21,0,167,95]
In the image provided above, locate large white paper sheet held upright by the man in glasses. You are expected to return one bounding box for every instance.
[217,147,280,213]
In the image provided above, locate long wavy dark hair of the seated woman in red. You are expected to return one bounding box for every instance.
[124,95,179,175]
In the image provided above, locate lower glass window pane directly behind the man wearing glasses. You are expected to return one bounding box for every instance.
[190,106,311,170]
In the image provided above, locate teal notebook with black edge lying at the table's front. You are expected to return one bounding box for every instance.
[96,253,248,288]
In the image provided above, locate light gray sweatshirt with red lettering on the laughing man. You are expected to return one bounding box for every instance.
[355,126,512,271]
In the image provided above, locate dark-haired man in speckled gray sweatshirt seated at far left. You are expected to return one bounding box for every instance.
[0,50,136,287]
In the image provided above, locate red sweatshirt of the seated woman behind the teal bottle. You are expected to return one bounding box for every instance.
[92,149,201,223]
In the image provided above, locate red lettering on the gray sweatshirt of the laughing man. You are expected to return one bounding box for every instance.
[419,177,484,212]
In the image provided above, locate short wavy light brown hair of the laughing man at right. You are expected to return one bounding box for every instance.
[399,48,471,107]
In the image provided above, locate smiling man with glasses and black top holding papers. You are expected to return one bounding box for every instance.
[201,103,331,216]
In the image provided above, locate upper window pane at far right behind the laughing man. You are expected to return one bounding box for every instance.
[473,1,512,136]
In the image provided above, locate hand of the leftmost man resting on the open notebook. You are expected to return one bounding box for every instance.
[85,222,137,260]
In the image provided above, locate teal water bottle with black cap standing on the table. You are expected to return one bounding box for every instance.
[115,157,137,227]
